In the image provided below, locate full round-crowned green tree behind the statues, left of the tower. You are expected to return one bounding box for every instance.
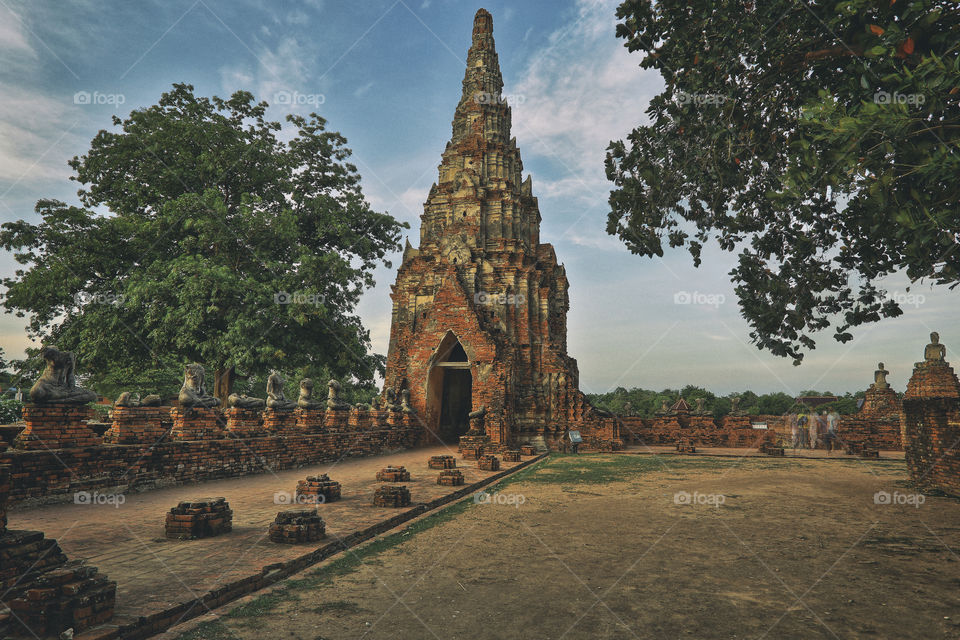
[0,84,406,396]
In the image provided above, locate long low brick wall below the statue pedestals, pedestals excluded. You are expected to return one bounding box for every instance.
[0,409,421,504]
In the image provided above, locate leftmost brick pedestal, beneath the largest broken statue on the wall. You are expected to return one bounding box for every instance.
[13,404,103,451]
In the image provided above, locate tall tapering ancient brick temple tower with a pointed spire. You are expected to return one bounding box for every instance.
[385,9,619,447]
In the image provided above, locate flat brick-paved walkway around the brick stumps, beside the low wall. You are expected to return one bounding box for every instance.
[9,446,529,624]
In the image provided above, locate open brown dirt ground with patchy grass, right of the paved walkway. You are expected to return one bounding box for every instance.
[172,455,960,640]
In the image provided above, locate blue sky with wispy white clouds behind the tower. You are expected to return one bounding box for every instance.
[0,0,960,394]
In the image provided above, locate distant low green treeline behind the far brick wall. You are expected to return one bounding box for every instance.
[587,385,863,418]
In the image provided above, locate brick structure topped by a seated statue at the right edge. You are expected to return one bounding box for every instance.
[901,333,960,497]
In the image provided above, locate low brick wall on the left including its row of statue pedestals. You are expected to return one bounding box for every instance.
[0,405,421,504]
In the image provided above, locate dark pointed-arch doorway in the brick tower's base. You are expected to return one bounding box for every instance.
[427,331,473,444]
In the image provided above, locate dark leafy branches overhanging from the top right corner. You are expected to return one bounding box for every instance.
[606,0,960,363]
